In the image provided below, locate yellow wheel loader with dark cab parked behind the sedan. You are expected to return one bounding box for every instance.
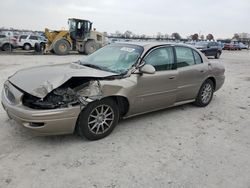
[45,18,107,55]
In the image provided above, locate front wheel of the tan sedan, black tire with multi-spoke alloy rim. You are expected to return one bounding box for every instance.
[76,98,119,140]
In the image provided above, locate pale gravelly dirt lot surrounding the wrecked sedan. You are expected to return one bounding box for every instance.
[0,51,250,188]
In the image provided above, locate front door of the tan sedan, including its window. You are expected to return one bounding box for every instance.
[132,46,178,113]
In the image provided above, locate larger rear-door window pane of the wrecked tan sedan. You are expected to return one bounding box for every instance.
[175,46,195,68]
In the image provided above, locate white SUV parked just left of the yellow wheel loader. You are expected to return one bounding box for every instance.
[17,35,47,50]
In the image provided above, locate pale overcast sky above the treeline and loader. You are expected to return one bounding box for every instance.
[0,0,250,38]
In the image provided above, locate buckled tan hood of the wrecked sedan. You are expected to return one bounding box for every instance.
[9,63,117,98]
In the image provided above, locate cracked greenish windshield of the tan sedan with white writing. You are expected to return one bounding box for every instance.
[80,44,143,74]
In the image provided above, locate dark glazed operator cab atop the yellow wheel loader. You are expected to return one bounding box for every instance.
[68,18,92,40]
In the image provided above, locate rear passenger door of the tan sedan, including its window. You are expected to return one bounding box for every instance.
[175,46,209,102]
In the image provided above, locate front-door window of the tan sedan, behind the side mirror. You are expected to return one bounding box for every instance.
[145,47,174,71]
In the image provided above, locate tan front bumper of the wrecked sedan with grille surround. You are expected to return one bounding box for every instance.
[2,82,80,135]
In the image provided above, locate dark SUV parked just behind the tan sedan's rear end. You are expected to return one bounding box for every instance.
[195,41,222,59]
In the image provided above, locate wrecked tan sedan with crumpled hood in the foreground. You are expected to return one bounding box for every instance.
[2,43,225,140]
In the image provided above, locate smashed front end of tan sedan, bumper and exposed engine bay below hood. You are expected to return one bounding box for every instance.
[2,79,102,135]
